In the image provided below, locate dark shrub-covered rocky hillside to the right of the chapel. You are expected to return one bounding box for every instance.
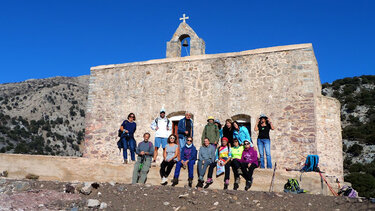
[322,75,375,197]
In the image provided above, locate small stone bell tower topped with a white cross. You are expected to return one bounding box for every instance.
[167,14,206,58]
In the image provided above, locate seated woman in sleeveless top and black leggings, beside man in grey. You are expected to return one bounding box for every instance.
[160,134,180,185]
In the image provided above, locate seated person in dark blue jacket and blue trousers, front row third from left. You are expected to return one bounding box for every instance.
[172,136,197,187]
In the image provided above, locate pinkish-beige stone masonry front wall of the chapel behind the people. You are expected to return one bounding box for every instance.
[84,44,341,178]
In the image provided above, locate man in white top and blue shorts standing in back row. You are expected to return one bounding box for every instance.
[151,108,172,162]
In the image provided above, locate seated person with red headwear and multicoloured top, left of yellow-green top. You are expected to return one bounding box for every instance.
[204,137,232,190]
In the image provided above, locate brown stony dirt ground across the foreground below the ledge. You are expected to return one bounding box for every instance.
[0,178,375,211]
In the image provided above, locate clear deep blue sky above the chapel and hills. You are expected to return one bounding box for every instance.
[0,0,375,83]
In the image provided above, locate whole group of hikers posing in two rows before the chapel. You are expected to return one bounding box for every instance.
[120,109,274,190]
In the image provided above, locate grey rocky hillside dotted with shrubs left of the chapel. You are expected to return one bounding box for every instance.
[0,76,89,156]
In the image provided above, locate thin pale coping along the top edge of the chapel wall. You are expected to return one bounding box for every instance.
[90,43,312,71]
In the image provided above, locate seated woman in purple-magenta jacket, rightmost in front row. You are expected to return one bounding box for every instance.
[240,140,258,191]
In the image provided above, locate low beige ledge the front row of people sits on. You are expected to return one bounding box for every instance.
[0,153,337,195]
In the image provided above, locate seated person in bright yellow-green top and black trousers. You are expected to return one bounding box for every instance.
[230,139,247,190]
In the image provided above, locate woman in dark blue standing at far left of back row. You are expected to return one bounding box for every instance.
[120,113,137,164]
